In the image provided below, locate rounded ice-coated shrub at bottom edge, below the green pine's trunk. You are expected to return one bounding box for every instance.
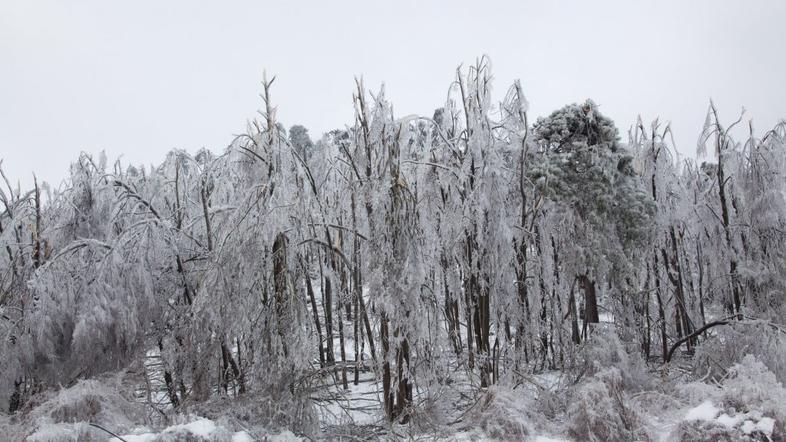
[568,368,650,441]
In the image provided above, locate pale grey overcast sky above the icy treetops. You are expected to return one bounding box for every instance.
[0,0,786,185]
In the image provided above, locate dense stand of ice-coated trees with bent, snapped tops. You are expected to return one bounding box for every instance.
[0,60,786,438]
